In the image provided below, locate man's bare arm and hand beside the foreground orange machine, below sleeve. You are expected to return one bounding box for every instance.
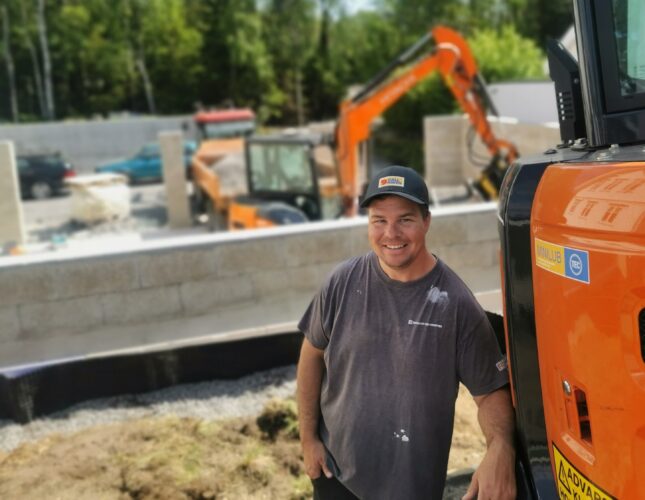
[462,388,516,500]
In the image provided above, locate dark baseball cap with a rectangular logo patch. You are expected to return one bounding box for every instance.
[361,165,430,208]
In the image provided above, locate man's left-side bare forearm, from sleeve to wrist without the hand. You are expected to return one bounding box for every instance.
[297,340,325,443]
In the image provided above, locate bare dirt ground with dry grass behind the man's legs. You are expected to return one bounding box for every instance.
[0,380,485,500]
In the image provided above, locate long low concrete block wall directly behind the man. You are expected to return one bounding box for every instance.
[0,203,499,367]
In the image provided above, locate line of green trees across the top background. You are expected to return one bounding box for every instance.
[0,0,572,125]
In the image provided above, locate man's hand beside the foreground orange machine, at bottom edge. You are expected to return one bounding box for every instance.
[462,441,517,500]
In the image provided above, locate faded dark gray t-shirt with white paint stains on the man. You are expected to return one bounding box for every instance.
[298,252,508,500]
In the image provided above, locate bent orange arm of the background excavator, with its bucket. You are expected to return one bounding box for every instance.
[336,26,518,216]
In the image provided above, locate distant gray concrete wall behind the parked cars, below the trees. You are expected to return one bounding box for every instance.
[0,115,195,172]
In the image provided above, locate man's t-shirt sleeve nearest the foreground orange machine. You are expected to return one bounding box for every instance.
[457,309,509,396]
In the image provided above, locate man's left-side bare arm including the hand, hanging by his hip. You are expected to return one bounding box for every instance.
[297,339,332,479]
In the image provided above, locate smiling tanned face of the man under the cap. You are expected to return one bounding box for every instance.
[368,196,430,279]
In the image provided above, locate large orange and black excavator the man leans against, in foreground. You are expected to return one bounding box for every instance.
[498,0,645,500]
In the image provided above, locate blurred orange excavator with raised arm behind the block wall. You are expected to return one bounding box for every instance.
[210,26,518,229]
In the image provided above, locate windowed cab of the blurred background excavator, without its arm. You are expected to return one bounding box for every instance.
[229,131,342,230]
